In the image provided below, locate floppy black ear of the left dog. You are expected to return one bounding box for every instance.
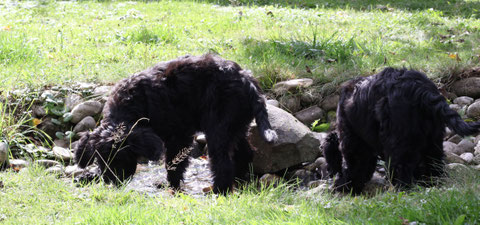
[127,127,164,161]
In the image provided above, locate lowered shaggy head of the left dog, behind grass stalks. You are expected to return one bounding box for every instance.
[75,124,163,183]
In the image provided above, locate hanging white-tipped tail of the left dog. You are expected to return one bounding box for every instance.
[244,74,278,143]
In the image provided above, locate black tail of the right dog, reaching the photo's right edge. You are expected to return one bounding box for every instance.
[421,92,480,136]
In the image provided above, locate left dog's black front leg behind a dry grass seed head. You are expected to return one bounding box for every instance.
[165,136,193,189]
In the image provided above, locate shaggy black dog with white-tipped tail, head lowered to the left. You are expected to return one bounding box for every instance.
[75,55,277,193]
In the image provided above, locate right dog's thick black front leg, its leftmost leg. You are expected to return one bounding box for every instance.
[335,130,377,194]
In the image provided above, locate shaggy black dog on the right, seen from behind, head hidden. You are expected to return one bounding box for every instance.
[323,68,480,194]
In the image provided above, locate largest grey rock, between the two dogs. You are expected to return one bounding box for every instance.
[248,105,324,174]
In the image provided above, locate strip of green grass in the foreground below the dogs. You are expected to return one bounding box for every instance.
[0,167,480,224]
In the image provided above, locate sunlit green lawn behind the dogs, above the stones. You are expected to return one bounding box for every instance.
[0,0,480,89]
